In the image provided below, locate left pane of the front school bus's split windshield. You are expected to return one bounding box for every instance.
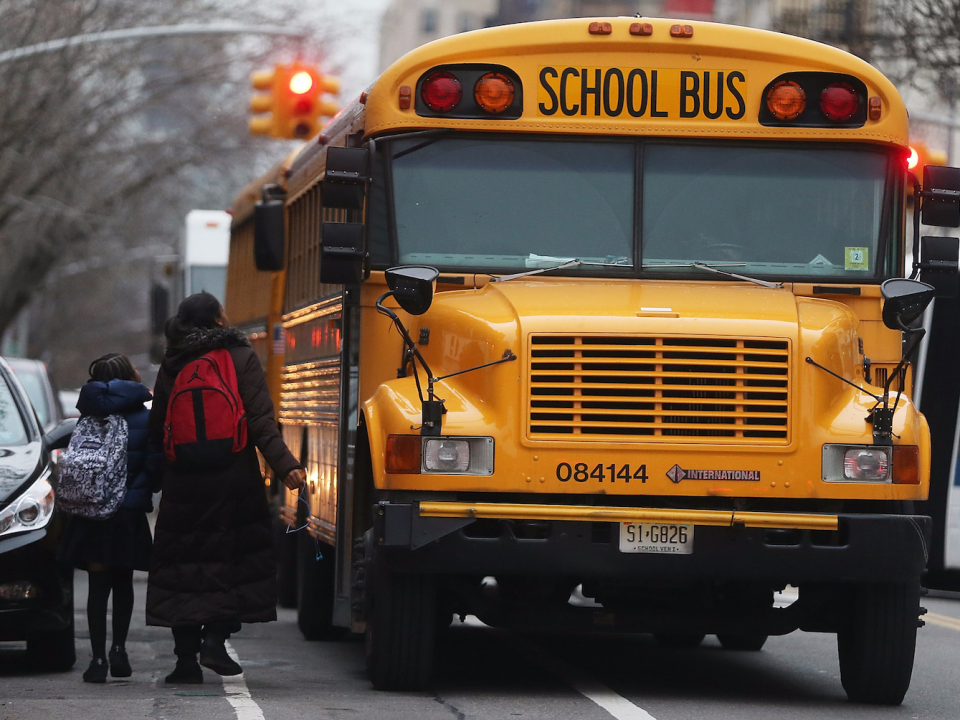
[393,138,636,272]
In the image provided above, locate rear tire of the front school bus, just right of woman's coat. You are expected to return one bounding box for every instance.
[296,530,344,640]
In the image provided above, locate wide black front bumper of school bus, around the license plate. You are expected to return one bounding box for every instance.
[374,503,931,584]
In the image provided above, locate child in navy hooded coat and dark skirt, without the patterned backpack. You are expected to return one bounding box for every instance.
[58,353,161,683]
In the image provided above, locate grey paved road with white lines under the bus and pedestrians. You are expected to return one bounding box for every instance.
[0,572,960,720]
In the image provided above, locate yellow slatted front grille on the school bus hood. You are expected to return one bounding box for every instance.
[528,335,790,445]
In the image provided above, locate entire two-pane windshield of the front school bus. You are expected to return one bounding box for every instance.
[391,136,896,282]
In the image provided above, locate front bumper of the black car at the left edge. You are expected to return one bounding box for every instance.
[0,530,73,641]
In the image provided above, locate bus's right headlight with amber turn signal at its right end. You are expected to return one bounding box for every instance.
[823,445,920,485]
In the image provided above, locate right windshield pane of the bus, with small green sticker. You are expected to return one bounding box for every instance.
[641,144,890,282]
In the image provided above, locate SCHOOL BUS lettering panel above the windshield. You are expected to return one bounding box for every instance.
[538,65,746,120]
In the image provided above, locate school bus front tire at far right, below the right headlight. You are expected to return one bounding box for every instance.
[837,582,920,705]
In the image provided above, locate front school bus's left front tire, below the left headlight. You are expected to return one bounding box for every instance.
[365,573,437,690]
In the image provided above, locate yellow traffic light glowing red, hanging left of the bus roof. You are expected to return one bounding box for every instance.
[250,62,340,139]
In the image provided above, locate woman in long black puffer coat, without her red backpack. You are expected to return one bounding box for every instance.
[147,293,304,683]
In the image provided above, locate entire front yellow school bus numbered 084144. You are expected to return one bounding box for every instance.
[238,18,960,704]
